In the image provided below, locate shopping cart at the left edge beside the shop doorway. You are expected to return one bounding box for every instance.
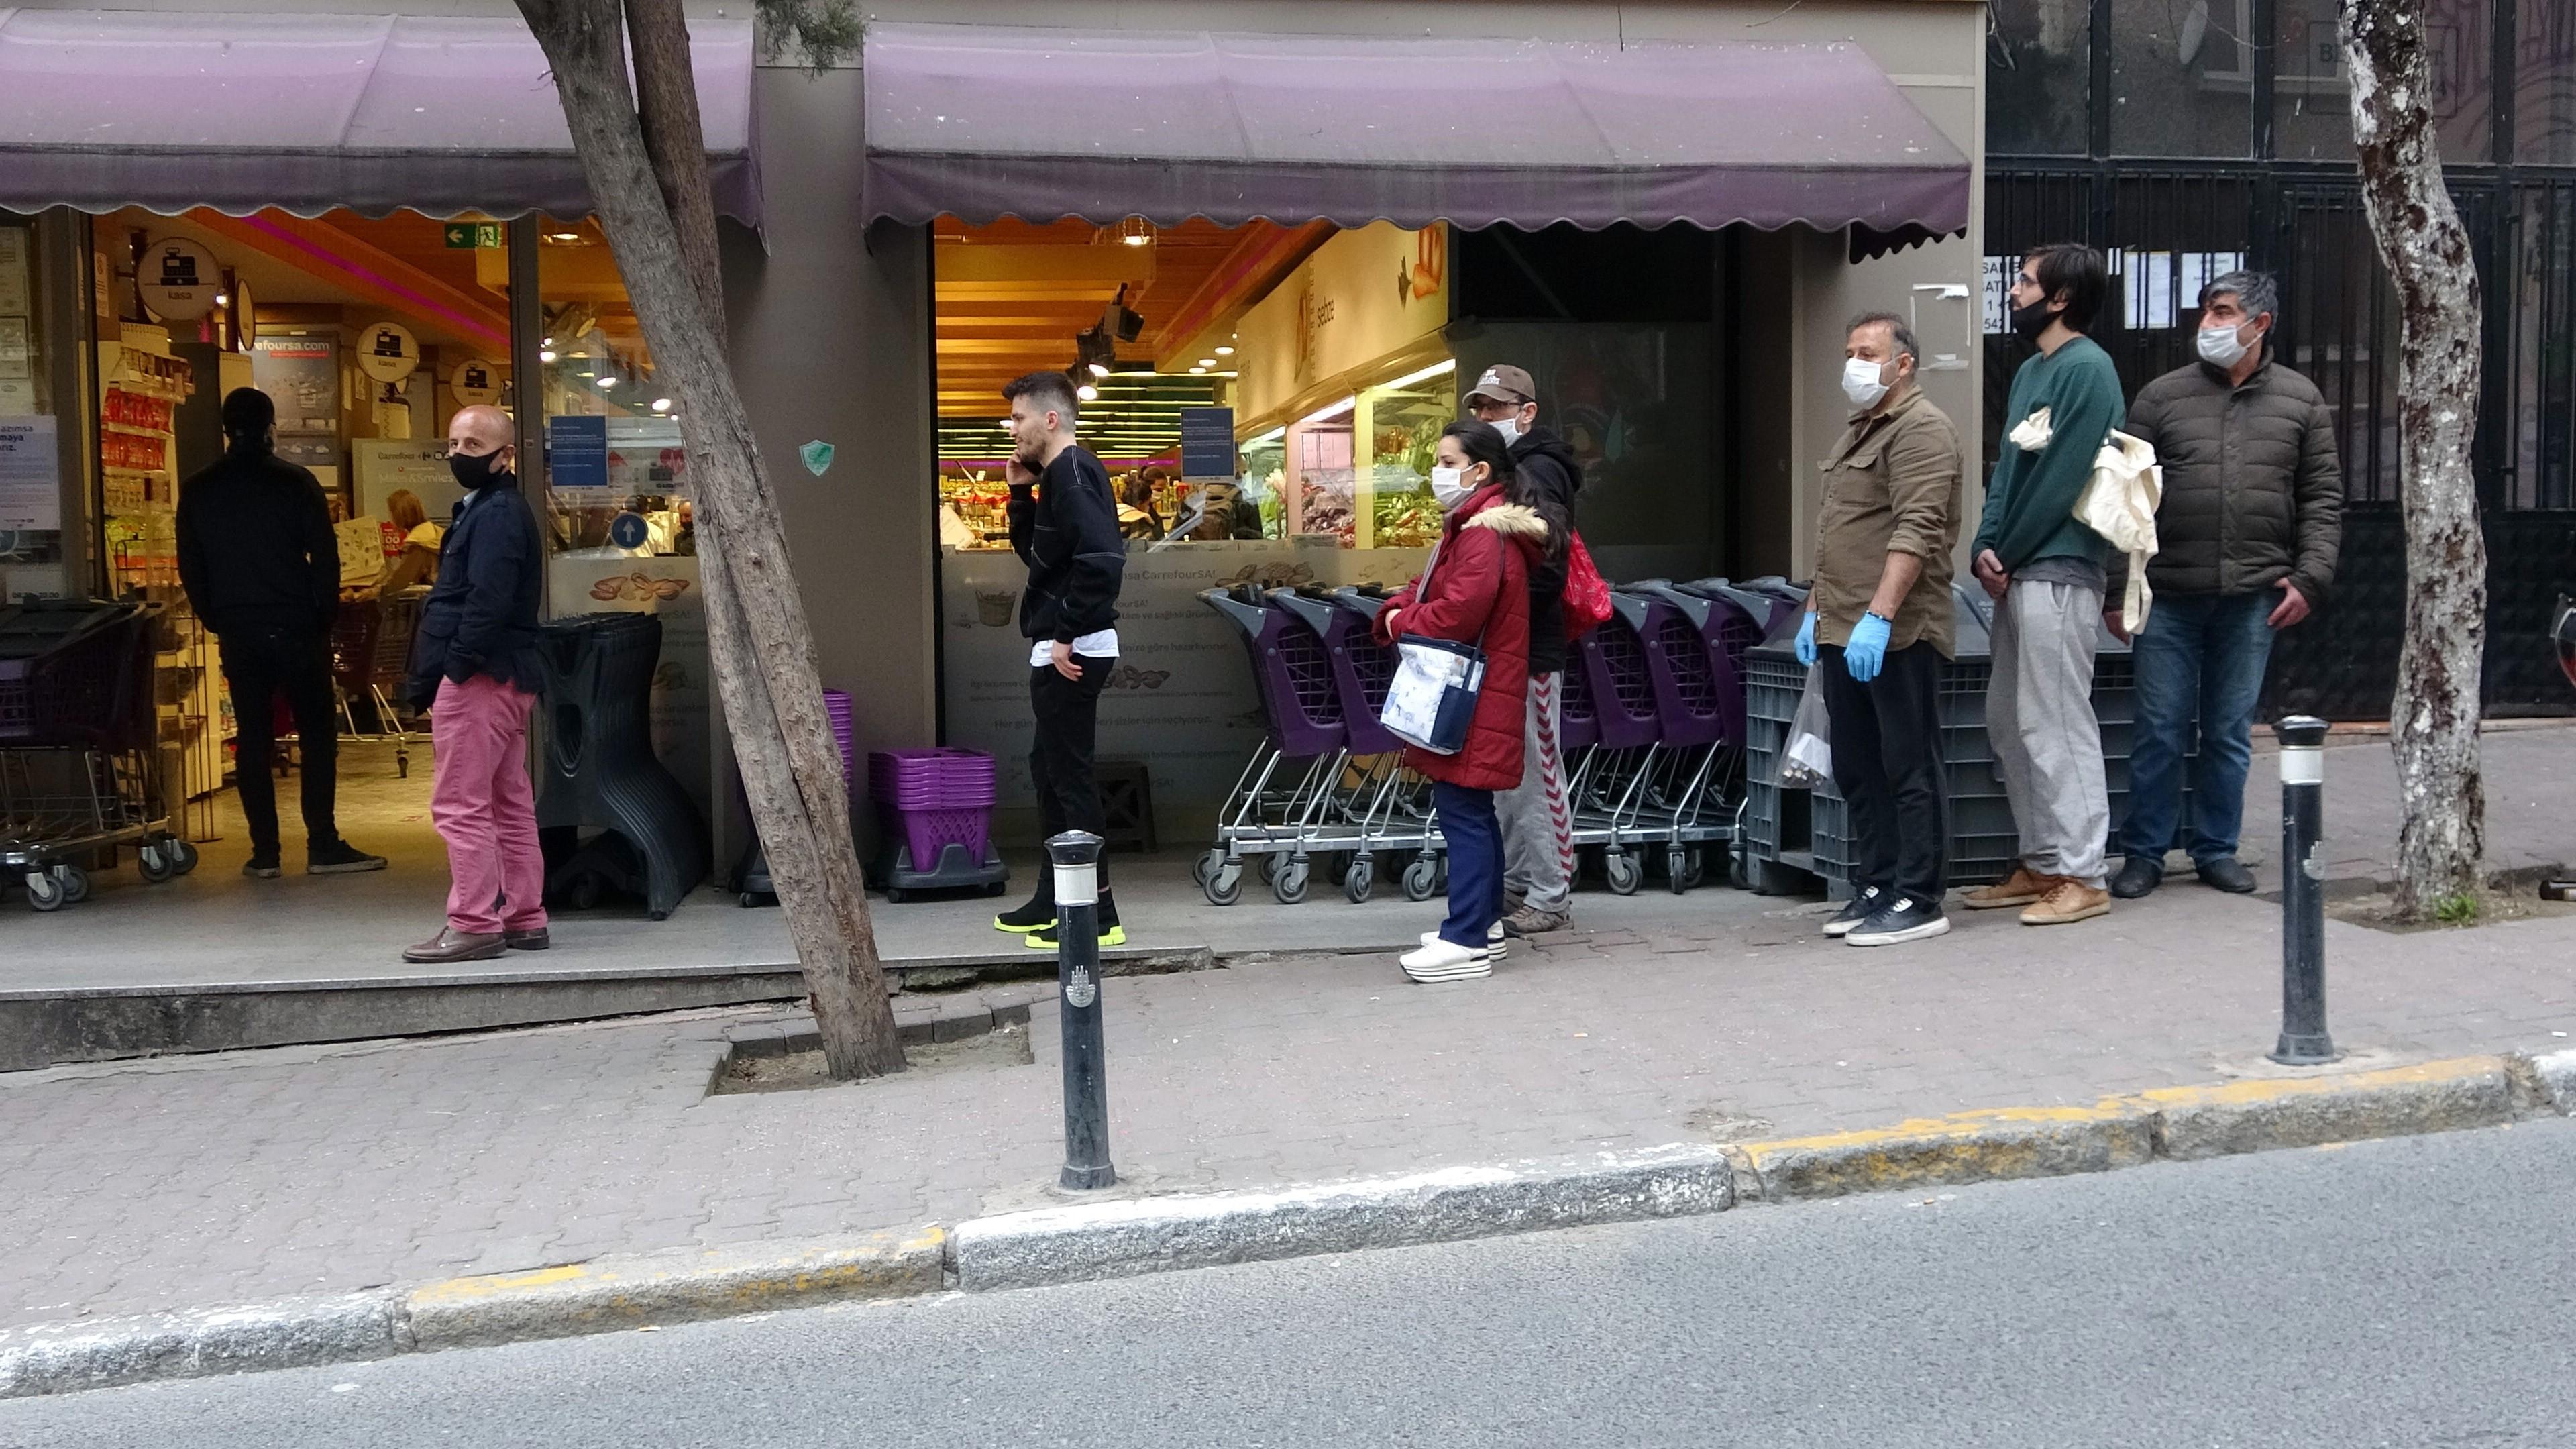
[0,603,196,910]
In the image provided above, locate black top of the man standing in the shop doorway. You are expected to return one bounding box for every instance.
[178,446,340,639]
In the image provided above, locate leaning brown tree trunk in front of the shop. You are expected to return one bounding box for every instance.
[521,0,904,1078]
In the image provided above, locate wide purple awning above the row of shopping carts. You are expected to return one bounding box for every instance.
[863,23,1971,232]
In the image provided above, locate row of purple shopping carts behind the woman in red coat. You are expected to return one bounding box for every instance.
[1195,578,1806,905]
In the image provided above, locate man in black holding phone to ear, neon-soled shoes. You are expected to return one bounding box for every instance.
[991,371,1126,951]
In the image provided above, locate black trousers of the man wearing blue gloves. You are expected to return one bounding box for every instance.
[1816,642,1950,905]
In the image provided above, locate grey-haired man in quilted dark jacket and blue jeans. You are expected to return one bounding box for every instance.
[2104,271,2344,900]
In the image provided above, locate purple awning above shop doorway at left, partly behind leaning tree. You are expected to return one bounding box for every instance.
[0,10,760,224]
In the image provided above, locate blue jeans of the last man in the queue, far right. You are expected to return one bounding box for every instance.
[2120,588,2279,866]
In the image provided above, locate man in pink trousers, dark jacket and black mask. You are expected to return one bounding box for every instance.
[402,405,551,962]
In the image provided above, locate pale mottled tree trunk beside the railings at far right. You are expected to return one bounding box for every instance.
[2342,0,2486,920]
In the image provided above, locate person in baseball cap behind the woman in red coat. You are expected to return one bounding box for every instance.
[1466,364,1585,936]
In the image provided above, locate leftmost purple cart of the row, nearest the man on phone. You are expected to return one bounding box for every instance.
[1193,585,1350,905]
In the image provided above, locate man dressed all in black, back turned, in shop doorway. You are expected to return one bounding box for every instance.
[178,387,384,879]
